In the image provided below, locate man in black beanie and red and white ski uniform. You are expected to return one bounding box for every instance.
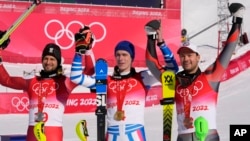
[0,26,94,141]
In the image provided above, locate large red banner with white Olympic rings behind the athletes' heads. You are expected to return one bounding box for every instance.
[0,0,181,67]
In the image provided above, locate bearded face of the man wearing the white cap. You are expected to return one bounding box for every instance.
[179,48,200,73]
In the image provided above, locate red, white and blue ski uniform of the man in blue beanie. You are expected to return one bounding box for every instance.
[71,40,178,141]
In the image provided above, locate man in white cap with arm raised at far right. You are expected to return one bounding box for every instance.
[148,3,245,141]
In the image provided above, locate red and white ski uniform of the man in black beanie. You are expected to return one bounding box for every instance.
[0,48,94,141]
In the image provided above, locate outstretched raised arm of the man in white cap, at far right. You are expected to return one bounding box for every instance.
[205,3,245,84]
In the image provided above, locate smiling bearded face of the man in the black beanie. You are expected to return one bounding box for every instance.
[42,55,58,72]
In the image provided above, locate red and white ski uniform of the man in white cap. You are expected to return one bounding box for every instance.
[148,4,242,141]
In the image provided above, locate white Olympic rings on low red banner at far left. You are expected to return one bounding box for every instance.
[11,96,29,112]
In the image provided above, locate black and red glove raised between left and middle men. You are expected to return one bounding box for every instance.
[75,26,94,54]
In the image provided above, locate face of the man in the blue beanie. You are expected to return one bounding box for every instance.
[115,50,132,72]
